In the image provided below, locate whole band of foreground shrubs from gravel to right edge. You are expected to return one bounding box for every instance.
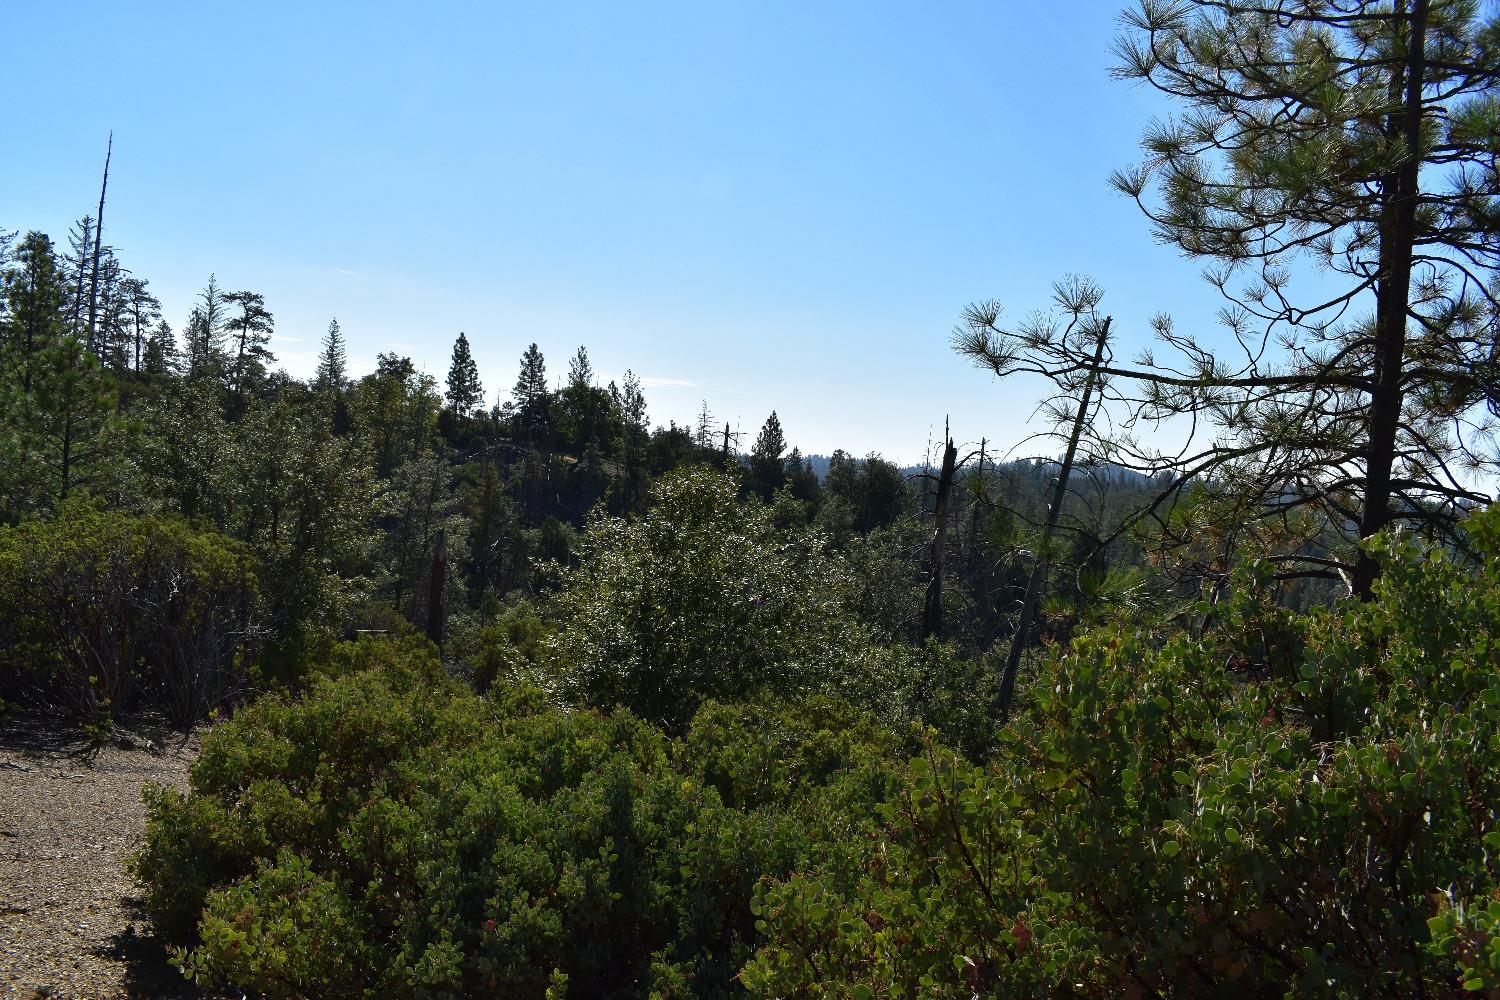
[138,514,1500,997]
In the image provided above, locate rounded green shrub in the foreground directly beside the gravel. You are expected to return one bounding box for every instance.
[137,637,894,997]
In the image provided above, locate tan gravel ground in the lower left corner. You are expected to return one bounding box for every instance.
[0,712,198,1000]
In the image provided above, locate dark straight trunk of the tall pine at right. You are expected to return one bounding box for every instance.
[1350,0,1428,601]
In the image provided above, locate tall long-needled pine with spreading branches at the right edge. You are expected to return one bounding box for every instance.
[1086,0,1500,598]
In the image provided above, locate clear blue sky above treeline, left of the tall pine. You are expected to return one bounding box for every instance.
[0,0,1215,460]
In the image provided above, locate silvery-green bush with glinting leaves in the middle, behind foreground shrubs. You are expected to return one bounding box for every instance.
[551,468,893,732]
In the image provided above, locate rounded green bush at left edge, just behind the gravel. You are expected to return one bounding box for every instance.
[0,505,260,726]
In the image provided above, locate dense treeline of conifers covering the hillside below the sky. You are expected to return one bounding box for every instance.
[0,219,1170,723]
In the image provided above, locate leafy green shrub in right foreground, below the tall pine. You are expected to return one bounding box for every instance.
[743,513,1500,997]
